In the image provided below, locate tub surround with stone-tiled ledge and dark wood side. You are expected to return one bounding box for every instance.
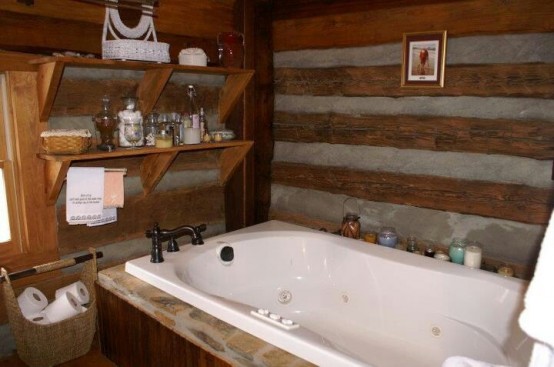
[96,265,313,367]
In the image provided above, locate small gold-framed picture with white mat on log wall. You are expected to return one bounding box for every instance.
[401,31,446,88]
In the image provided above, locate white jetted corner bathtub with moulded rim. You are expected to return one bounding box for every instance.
[125,221,532,367]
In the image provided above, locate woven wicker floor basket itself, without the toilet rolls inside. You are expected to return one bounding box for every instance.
[2,251,97,367]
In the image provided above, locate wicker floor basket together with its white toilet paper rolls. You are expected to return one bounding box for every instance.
[1,249,97,367]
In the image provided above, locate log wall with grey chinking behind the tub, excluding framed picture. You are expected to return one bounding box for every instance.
[270,0,554,269]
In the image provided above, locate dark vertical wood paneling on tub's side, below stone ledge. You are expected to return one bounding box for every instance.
[96,286,231,367]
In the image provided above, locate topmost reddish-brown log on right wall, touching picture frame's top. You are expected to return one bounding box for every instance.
[273,0,554,50]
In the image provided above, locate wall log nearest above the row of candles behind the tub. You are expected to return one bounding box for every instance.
[273,162,554,224]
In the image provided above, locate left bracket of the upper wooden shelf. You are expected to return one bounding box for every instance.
[37,61,65,122]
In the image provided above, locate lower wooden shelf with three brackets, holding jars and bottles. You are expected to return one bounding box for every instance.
[38,140,254,205]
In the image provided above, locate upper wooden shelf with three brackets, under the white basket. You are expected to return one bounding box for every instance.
[29,57,254,123]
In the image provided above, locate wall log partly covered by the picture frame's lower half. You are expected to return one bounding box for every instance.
[275,64,554,99]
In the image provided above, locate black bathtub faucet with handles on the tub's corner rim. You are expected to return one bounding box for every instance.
[145,223,207,263]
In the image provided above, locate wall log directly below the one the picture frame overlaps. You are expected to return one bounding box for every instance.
[273,112,554,159]
